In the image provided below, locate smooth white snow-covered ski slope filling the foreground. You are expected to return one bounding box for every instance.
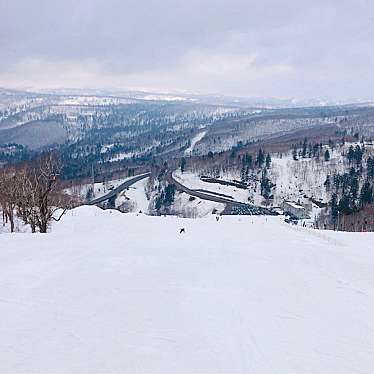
[0,207,374,373]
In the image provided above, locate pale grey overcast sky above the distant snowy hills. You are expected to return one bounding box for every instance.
[0,0,374,101]
